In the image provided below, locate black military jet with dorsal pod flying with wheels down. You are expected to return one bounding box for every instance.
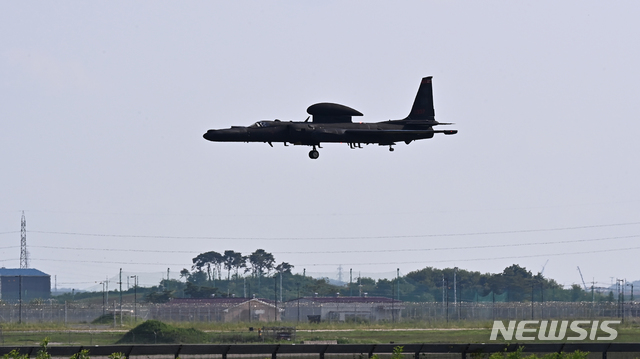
[203,77,458,159]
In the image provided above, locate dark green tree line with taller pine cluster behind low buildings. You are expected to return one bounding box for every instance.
[142,249,611,302]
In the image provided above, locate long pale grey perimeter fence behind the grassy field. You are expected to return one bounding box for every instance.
[0,302,640,324]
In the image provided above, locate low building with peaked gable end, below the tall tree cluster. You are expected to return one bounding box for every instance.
[152,298,284,323]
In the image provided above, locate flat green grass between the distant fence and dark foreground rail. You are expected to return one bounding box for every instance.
[0,322,640,345]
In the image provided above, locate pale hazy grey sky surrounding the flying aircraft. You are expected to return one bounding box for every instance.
[0,1,640,289]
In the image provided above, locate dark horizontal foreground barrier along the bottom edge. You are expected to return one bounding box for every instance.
[0,343,640,359]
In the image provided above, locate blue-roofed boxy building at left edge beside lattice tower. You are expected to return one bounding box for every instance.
[0,268,51,303]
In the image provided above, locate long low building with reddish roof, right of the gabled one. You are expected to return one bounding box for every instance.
[284,296,404,322]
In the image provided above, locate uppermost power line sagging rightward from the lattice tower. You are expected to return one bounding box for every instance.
[29,222,640,241]
